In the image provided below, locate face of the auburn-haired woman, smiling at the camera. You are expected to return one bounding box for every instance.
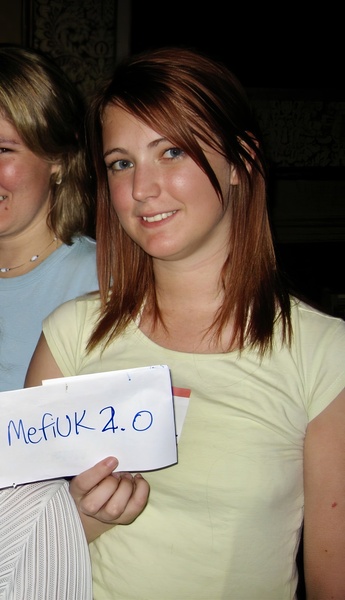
[103,105,237,261]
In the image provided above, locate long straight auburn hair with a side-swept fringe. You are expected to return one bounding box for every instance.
[87,47,291,354]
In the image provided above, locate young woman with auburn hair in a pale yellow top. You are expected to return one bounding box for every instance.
[27,48,345,600]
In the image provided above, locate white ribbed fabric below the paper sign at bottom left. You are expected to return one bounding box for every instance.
[0,480,92,600]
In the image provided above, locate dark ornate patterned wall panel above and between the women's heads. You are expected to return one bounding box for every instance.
[23,0,117,98]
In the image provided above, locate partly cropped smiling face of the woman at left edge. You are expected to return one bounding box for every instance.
[0,116,58,237]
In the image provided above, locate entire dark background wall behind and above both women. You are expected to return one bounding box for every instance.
[0,0,345,317]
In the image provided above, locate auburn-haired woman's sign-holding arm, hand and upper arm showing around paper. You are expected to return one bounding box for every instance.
[25,333,149,542]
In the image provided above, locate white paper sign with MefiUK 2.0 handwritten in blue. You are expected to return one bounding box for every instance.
[0,365,177,487]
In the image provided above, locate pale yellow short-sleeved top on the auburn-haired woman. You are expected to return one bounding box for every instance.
[44,299,345,600]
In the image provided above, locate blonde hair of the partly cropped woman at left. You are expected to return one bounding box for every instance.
[0,45,94,244]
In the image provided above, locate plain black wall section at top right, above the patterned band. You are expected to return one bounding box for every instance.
[131,0,344,89]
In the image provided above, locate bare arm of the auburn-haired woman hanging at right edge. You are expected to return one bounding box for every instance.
[304,390,345,600]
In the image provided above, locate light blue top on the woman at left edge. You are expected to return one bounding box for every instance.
[0,237,98,391]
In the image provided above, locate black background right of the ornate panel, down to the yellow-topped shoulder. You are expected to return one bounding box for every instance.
[131,0,345,316]
